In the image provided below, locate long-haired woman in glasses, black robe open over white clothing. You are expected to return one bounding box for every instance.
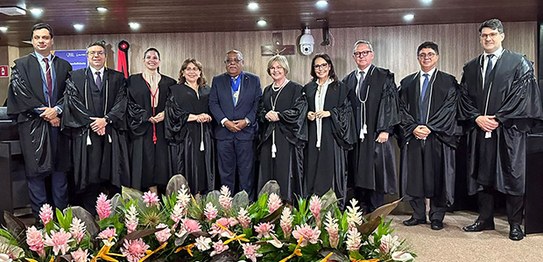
[303,54,356,206]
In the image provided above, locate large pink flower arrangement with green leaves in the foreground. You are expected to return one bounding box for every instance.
[0,176,415,262]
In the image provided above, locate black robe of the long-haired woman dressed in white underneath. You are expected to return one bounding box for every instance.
[302,81,356,205]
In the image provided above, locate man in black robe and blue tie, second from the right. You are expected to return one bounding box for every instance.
[400,42,459,230]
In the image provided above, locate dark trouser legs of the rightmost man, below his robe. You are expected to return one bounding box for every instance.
[477,187,524,225]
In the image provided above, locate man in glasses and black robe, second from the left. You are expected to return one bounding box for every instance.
[62,41,130,212]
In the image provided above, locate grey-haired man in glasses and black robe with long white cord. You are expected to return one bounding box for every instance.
[343,40,400,212]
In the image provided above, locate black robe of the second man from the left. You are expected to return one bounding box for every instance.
[62,68,130,191]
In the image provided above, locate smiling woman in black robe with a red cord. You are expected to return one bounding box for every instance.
[127,48,175,191]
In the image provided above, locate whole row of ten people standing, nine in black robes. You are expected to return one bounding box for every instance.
[8,19,543,240]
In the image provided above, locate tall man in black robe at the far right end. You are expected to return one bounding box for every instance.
[459,19,543,240]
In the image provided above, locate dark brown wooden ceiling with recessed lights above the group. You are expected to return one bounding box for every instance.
[0,0,539,46]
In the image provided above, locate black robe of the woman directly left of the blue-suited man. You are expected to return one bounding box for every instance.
[165,84,216,194]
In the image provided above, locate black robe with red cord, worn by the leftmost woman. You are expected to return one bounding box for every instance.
[127,74,175,191]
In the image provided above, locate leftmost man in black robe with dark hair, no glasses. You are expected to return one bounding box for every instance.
[7,23,72,217]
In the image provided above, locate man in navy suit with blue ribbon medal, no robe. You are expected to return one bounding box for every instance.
[209,50,262,199]
